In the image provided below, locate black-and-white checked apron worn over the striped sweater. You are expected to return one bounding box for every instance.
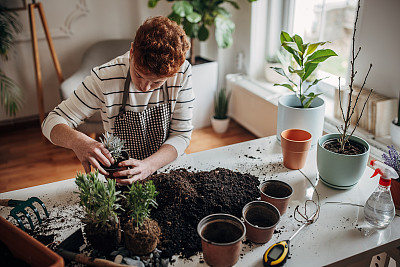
[114,69,171,160]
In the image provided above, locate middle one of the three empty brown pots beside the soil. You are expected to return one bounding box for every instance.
[242,200,281,244]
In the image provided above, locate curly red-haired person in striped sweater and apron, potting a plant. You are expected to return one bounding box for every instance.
[42,16,195,184]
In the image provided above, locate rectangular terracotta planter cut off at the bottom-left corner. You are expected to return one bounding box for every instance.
[0,217,64,267]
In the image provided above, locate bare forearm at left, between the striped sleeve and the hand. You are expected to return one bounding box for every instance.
[50,124,90,149]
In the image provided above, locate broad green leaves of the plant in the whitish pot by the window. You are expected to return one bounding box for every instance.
[271,31,337,108]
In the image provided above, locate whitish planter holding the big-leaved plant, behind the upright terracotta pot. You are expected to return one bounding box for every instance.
[276,94,325,149]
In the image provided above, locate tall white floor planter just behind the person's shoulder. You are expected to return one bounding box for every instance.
[192,58,218,129]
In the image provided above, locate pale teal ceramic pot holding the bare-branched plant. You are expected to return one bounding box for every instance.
[317,134,370,189]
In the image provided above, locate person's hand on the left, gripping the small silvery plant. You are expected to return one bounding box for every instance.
[72,135,114,176]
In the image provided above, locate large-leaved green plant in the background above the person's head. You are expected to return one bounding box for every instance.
[148,0,257,65]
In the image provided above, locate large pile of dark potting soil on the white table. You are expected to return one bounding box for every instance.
[147,168,260,258]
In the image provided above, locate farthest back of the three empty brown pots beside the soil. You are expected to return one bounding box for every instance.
[259,180,293,215]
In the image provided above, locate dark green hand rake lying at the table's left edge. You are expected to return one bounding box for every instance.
[0,197,49,231]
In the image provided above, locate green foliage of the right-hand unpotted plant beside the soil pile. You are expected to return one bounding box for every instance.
[127,180,158,227]
